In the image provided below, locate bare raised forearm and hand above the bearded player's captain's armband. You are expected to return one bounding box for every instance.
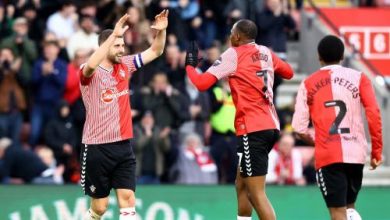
[141,10,169,64]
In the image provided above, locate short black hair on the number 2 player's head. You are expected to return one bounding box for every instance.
[317,35,344,63]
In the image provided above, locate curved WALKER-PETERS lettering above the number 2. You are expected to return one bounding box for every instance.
[307,77,359,105]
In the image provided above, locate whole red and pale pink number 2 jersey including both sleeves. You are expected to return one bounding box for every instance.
[292,65,382,169]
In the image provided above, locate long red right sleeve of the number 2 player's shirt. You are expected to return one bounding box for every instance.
[359,74,383,160]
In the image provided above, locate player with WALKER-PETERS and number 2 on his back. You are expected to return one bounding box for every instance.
[292,35,382,220]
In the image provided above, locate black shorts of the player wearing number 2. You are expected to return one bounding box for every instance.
[316,163,364,207]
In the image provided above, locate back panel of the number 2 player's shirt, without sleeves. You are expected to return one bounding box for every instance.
[303,65,367,168]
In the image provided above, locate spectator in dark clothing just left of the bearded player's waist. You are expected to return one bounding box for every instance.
[44,100,77,182]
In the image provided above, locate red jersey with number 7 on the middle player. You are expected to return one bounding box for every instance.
[207,43,293,136]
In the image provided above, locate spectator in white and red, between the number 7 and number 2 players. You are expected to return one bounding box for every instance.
[266,134,305,185]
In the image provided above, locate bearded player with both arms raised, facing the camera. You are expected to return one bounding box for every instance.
[80,10,168,220]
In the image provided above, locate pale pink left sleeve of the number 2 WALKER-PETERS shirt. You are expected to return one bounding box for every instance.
[292,81,310,134]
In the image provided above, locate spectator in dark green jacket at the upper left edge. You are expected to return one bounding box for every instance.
[1,17,38,87]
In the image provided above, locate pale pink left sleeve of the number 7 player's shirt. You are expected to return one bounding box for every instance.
[206,48,237,80]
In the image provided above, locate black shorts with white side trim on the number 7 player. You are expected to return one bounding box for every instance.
[237,129,279,177]
